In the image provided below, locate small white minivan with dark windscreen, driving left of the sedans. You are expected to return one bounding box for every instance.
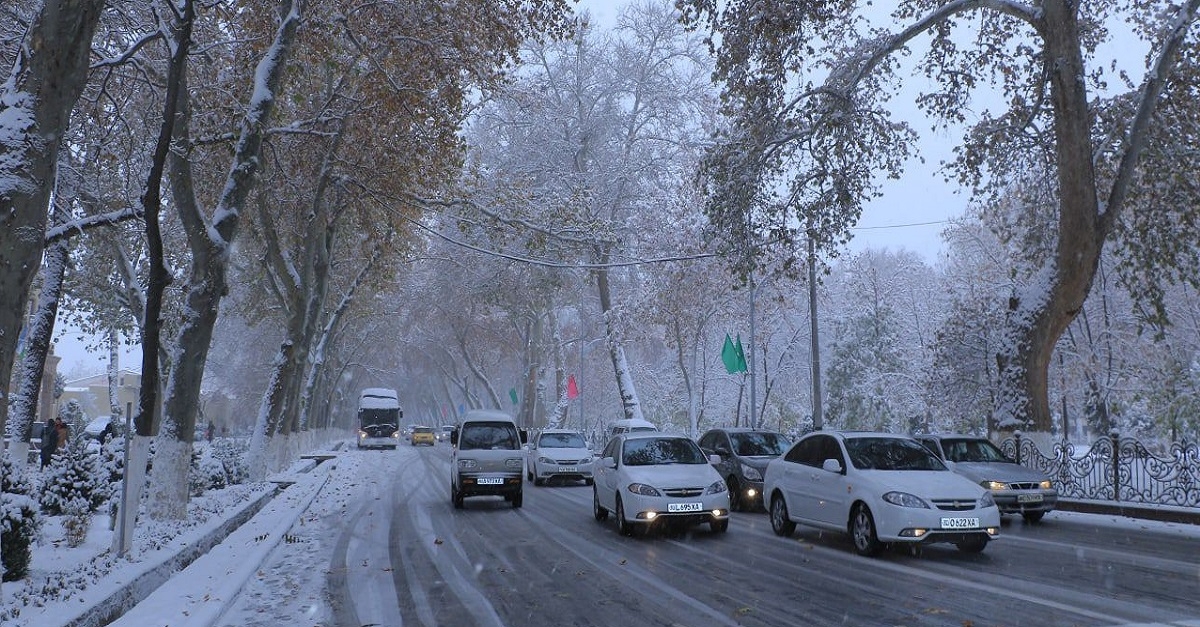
[450,410,526,509]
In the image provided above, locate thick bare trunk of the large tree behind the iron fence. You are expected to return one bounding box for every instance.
[997,0,1104,432]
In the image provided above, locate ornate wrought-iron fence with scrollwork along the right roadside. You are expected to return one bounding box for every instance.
[1000,431,1200,507]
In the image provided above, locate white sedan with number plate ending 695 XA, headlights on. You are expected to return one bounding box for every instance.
[592,432,730,536]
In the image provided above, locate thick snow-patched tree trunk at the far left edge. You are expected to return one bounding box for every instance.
[0,0,106,432]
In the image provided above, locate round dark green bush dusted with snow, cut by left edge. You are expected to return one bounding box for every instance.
[0,450,41,581]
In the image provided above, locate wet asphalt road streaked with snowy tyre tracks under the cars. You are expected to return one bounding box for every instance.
[222,444,1200,627]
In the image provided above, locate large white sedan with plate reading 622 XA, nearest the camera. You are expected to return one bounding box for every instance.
[763,431,1000,555]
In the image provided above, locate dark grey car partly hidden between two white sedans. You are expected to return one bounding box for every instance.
[698,428,792,512]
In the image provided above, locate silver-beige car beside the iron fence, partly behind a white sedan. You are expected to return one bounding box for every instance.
[913,434,1058,523]
